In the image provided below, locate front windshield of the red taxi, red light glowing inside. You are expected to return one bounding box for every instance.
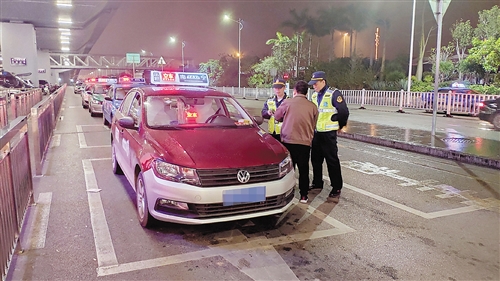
[144,95,253,128]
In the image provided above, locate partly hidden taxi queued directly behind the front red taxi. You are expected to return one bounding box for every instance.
[102,77,145,126]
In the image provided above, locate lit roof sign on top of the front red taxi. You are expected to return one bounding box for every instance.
[147,70,209,87]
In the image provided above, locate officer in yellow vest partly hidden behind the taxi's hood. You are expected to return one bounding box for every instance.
[262,78,287,141]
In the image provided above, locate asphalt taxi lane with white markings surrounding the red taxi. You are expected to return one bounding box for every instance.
[7,88,500,280]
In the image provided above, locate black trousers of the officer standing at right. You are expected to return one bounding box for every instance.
[311,131,343,190]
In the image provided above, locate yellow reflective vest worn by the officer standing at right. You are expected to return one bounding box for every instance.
[311,89,339,132]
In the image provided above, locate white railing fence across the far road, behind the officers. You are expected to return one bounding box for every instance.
[216,87,500,116]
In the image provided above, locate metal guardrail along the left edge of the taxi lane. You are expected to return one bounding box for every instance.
[0,85,66,280]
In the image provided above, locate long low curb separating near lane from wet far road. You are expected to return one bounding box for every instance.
[338,132,500,170]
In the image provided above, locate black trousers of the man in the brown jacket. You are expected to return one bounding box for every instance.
[284,143,311,196]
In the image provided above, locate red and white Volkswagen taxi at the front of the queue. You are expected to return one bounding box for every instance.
[111,71,295,227]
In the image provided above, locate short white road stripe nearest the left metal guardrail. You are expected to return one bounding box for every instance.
[28,192,52,249]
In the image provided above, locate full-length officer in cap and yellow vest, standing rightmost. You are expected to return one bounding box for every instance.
[309,71,349,197]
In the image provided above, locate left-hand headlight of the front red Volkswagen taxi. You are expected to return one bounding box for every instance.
[153,159,200,185]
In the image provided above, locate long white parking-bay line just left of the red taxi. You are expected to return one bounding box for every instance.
[82,158,118,267]
